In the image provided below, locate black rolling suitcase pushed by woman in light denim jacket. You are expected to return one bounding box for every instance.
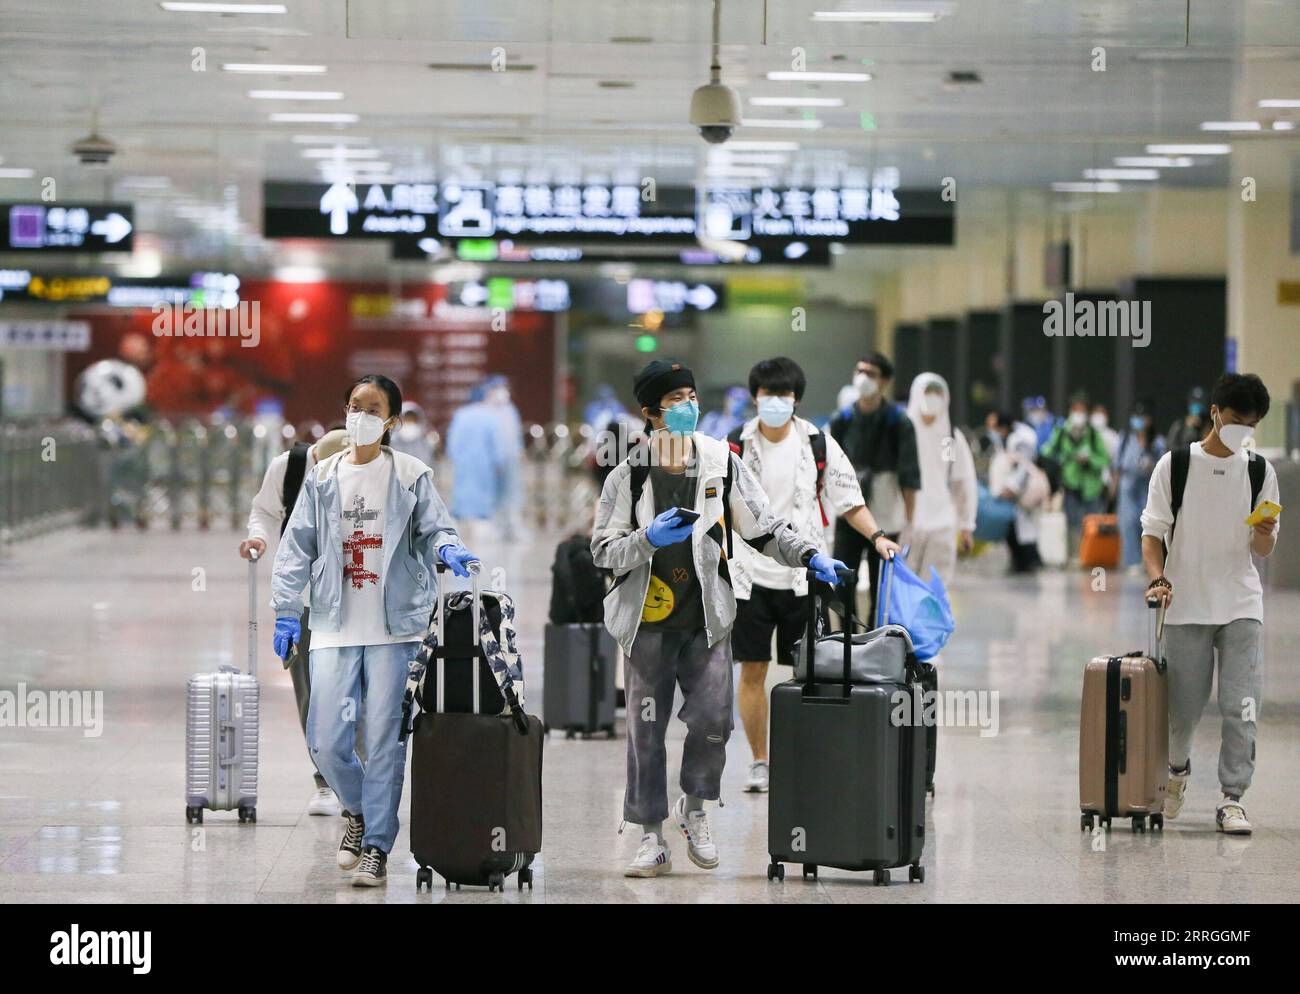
[402,565,543,890]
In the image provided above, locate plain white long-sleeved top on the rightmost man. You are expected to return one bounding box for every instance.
[1141,442,1281,625]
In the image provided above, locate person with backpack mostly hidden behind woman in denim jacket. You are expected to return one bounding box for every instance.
[239,429,360,815]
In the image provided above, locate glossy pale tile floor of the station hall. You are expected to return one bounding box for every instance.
[0,522,1300,903]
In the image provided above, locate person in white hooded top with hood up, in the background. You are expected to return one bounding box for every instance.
[905,373,978,582]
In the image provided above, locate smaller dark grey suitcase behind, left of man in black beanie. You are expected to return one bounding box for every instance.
[542,624,619,738]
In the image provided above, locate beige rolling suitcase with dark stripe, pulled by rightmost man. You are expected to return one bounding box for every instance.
[1079,602,1169,832]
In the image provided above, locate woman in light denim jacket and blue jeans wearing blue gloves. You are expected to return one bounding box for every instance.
[272,376,476,886]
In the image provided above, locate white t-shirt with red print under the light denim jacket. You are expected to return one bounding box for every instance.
[312,455,423,648]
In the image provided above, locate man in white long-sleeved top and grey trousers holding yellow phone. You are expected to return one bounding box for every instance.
[1141,373,1278,835]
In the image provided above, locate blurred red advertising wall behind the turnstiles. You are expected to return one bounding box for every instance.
[68,279,556,429]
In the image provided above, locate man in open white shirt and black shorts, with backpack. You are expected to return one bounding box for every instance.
[727,356,898,794]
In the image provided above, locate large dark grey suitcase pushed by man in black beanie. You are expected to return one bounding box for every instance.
[767,572,927,884]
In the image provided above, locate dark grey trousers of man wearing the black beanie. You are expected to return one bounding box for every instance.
[623,628,732,825]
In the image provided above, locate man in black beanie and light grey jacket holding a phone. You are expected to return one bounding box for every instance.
[592,359,844,877]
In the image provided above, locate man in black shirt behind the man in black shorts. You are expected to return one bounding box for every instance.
[829,352,920,624]
